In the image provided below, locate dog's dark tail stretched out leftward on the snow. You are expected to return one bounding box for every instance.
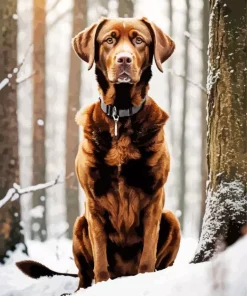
[16,260,78,279]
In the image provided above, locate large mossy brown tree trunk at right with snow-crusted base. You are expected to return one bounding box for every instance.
[193,0,247,263]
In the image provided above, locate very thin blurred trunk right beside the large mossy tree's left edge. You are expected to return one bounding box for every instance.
[199,1,209,235]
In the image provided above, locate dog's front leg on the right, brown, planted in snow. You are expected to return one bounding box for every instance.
[138,201,162,273]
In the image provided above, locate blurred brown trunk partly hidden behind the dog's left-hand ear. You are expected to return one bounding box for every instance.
[66,0,87,238]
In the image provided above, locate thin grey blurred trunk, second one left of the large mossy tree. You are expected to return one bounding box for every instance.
[179,0,190,230]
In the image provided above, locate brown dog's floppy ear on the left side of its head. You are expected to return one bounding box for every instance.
[72,18,106,70]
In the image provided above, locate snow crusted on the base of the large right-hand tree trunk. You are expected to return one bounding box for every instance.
[195,180,247,261]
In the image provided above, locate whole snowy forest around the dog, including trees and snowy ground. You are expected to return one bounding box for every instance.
[0,0,247,296]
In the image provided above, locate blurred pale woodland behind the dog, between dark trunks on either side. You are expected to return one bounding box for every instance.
[0,0,209,254]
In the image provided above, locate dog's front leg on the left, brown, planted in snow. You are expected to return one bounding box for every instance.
[89,215,110,283]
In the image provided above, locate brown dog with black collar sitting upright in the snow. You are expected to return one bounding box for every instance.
[18,18,180,288]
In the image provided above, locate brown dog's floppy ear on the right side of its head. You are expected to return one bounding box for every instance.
[141,17,175,72]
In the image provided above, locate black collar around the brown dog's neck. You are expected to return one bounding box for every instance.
[99,98,146,120]
